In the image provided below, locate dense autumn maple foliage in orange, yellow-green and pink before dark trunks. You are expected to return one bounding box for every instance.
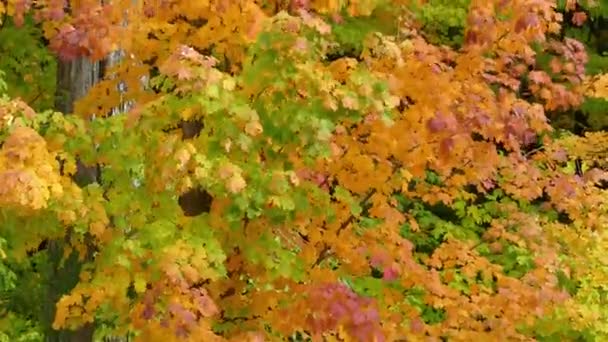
[0,0,607,341]
